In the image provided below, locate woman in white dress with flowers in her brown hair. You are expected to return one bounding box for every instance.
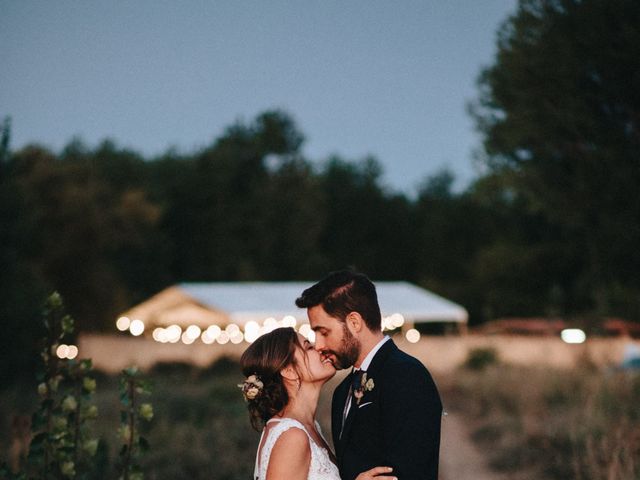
[238,328,395,480]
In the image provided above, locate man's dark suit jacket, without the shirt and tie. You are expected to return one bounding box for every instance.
[331,340,442,480]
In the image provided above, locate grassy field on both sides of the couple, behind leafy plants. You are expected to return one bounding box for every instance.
[0,350,640,480]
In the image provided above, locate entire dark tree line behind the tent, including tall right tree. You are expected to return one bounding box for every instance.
[0,0,640,376]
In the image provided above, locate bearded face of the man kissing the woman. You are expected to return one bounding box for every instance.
[307,305,360,370]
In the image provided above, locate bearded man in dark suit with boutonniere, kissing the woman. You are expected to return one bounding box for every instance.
[296,271,442,480]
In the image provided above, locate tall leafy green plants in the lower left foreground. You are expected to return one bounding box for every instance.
[0,292,154,480]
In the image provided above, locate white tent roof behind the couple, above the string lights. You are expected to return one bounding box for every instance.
[122,282,468,330]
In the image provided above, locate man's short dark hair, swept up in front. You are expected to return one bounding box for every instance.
[296,270,382,332]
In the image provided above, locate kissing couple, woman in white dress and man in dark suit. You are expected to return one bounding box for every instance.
[240,271,442,480]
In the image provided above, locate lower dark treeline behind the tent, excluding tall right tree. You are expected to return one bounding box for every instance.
[1,111,630,330]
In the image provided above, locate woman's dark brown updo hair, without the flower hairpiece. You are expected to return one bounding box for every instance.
[240,327,302,431]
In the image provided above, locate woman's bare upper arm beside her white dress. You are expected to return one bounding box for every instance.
[267,428,311,480]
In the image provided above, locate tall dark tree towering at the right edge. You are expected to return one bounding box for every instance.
[473,0,640,314]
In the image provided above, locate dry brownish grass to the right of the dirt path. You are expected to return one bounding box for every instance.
[448,363,640,480]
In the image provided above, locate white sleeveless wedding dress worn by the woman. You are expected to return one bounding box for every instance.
[253,418,340,480]
